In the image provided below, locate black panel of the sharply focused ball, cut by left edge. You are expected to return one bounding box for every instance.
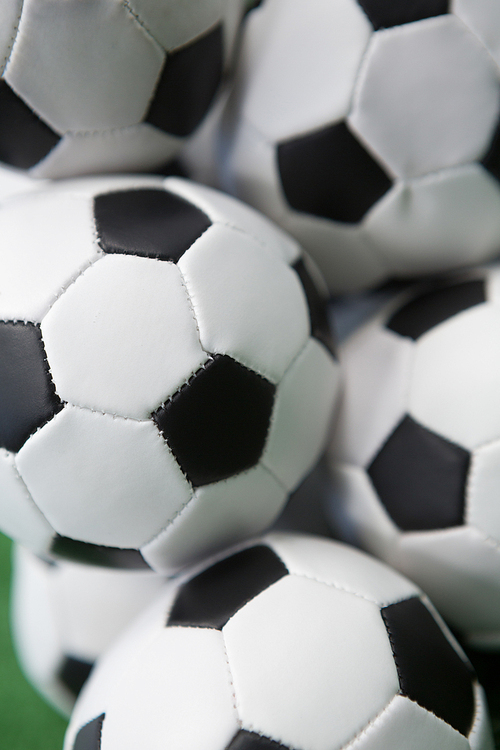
[0,321,63,452]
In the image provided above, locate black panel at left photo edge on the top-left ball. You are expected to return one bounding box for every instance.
[0,80,61,169]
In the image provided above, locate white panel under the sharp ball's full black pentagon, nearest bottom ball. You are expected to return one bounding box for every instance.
[141,466,287,575]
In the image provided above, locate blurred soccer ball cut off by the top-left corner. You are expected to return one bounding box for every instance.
[0,0,244,177]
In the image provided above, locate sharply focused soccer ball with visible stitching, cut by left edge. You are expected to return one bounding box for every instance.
[0,176,339,573]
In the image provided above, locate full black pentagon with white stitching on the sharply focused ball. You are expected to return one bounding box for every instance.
[152,354,276,487]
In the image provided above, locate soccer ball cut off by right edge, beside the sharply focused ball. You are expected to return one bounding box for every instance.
[330,265,500,648]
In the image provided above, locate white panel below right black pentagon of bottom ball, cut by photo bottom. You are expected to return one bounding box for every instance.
[346,695,470,750]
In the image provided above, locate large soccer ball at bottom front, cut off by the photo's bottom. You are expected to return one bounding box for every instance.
[64,534,493,750]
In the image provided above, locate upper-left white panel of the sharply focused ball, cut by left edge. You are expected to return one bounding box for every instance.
[0,191,99,322]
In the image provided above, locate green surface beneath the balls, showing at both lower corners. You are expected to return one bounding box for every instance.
[0,534,500,750]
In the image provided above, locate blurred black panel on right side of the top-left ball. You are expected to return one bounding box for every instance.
[145,25,224,137]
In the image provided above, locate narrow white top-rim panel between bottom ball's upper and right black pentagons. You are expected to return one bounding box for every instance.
[266,533,420,607]
